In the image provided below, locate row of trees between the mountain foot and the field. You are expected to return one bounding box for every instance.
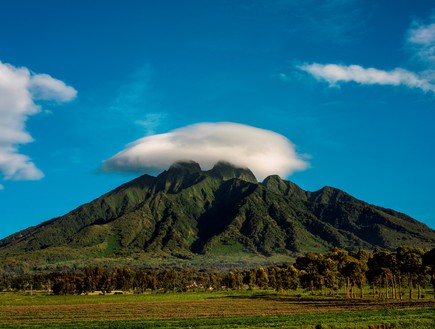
[0,246,435,299]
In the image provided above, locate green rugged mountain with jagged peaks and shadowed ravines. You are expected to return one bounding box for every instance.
[0,162,435,268]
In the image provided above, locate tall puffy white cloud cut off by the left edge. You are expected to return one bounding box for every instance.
[0,61,77,180]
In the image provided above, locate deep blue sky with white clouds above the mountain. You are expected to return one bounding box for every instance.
[0,0,435,238]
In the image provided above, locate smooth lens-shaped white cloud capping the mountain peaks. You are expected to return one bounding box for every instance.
[103,122,308,180]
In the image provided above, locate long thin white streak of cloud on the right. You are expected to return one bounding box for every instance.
[299,63,435,92]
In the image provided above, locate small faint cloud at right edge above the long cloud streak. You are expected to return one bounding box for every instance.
[406,17,435,62]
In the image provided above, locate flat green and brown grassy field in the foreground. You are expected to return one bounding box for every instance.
[0,291,435,329]
